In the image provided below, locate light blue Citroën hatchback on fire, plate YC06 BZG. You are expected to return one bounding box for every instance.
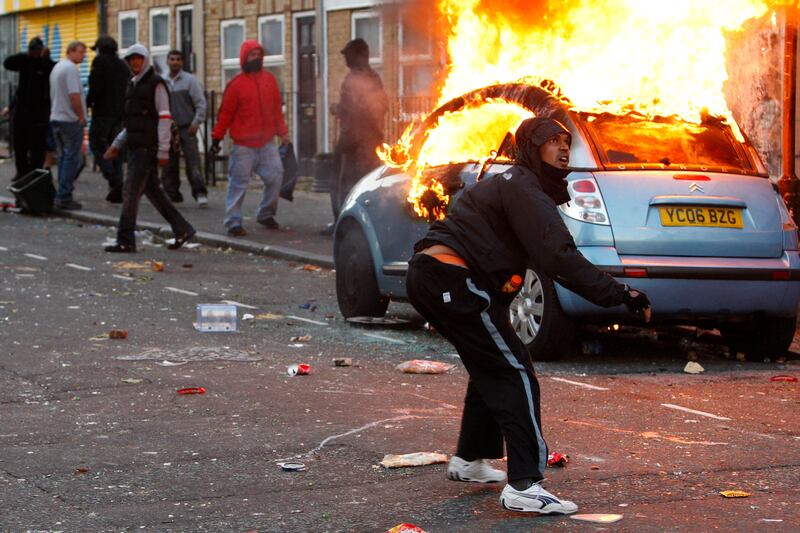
[334,82,800,360]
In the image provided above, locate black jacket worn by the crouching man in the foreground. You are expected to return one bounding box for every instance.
[414,118,625,307]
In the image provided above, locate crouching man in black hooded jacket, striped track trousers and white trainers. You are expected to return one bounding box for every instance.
[406,118,650,514]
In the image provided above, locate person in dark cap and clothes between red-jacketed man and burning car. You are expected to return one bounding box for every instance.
[323,38,389,235]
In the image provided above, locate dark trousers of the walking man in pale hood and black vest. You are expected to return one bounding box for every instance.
[117,148,192,246]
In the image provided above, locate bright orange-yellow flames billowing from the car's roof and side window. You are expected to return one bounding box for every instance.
[381,0,796,216]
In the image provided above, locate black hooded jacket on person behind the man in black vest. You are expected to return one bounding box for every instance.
[86,37,131,119]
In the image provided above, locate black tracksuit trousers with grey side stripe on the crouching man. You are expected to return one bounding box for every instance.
[406,254,547,481]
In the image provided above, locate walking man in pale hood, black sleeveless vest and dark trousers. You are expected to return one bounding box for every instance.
[104,43,195,253]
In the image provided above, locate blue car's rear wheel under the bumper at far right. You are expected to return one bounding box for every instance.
[720,316,797,363]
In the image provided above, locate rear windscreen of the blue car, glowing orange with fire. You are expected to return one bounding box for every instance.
[583,114,756,174]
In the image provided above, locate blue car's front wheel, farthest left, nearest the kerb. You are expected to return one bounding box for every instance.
[334,227,389,318]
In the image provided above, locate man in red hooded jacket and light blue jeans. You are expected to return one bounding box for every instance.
[211,40,289,237]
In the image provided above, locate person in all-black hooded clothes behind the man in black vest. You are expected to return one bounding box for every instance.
[86,35,131,204]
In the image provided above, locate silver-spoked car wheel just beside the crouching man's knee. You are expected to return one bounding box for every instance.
[509,270,575,361]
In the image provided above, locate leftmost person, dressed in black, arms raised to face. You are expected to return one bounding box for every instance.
[3,37,55,177]
